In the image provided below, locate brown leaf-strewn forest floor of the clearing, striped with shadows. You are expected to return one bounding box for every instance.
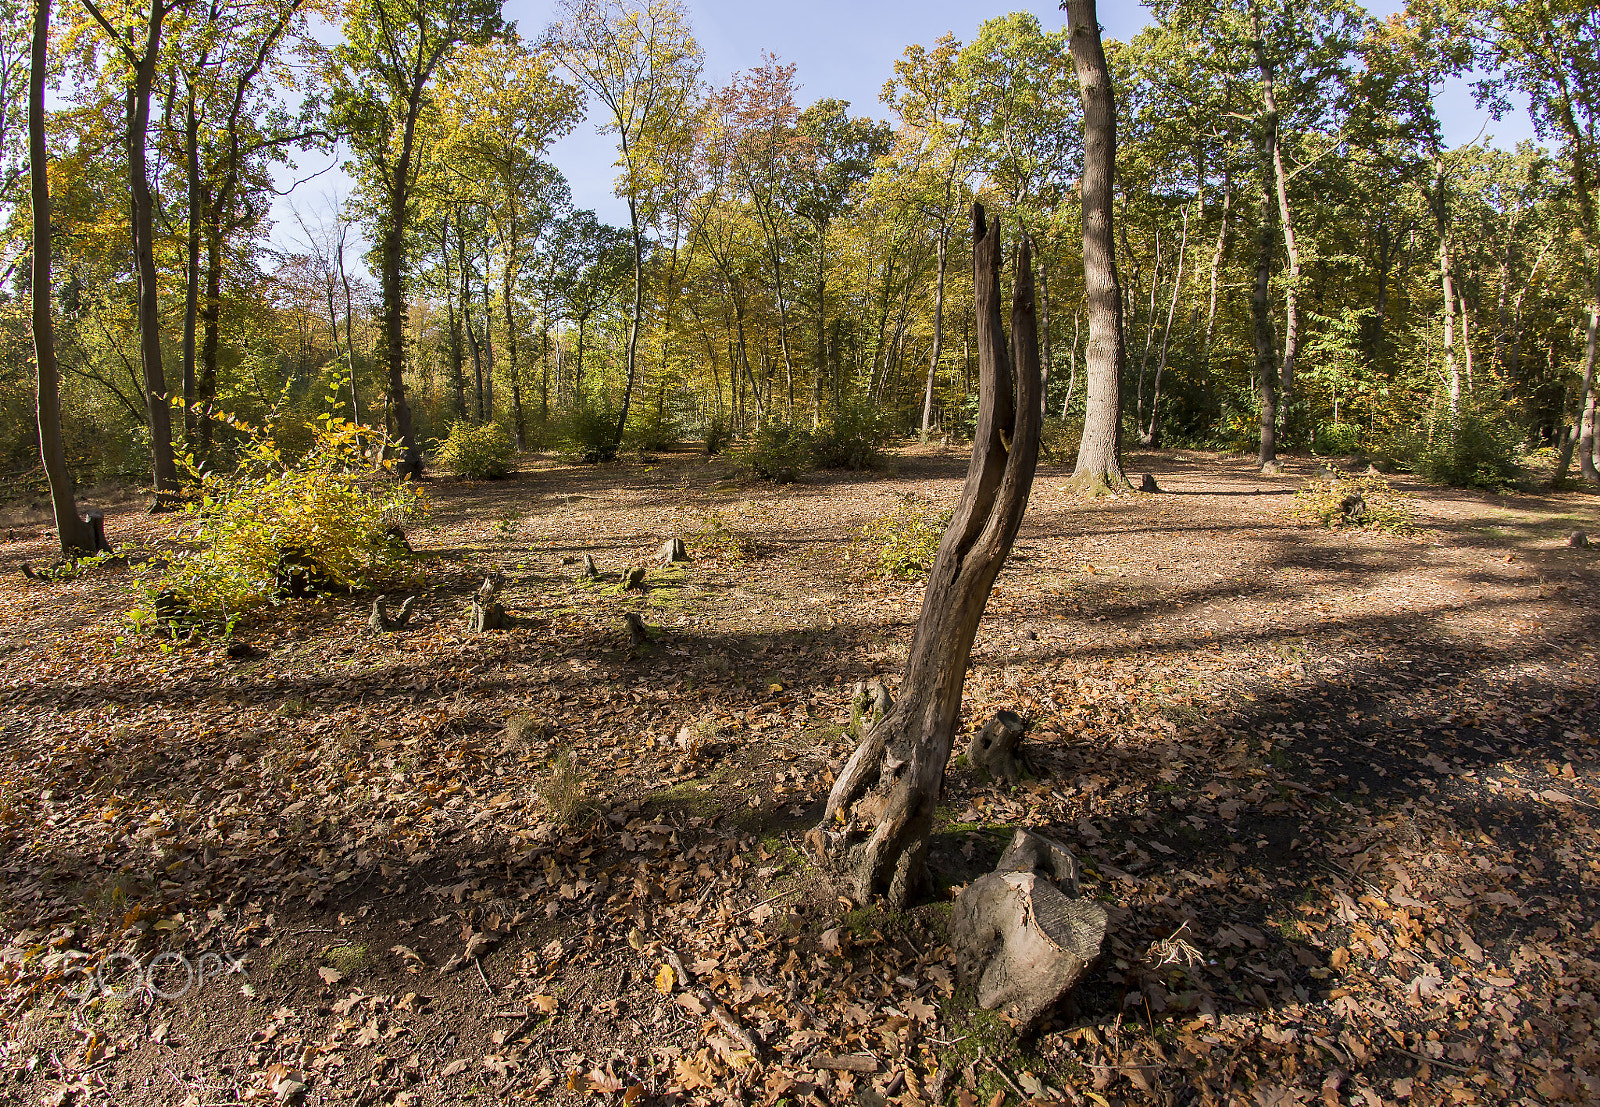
[0,448,1600,1107]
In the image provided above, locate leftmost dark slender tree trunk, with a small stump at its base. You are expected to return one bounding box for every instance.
[27,0,94,557]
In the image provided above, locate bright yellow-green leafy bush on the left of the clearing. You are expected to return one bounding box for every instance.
[128,416,426,629]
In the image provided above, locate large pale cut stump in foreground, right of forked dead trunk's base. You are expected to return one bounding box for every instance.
[950,830,1107,1027]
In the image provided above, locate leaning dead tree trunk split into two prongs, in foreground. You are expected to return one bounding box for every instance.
[808,205,1040,907]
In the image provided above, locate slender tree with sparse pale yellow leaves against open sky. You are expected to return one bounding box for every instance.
[546,0,704,445]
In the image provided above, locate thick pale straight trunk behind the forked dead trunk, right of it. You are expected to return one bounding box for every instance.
[1067,0,1130,491]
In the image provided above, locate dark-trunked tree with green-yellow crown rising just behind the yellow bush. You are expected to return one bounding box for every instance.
[336,0,506,478]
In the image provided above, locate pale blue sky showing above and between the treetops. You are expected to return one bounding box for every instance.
[274,0,1533,254]
